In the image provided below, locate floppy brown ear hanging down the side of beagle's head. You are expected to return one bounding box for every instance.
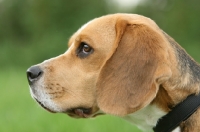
[97,21,166,115]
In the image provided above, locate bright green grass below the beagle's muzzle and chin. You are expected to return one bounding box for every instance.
[0,68,140,132]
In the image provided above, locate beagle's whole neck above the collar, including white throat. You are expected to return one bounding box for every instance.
[124,33,200,132]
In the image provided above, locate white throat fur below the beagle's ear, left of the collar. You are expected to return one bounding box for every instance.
[124,105,166,132]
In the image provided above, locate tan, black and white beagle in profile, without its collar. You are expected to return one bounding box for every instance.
[27,14,200,132]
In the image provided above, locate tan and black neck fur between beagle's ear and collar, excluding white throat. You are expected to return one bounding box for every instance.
[161,32,200,105]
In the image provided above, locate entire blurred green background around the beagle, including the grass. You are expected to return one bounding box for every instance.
[0,0,200,132]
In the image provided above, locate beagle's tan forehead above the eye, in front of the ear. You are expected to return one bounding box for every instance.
[68,16,116,47]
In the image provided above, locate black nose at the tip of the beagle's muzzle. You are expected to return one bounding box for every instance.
[26,66,43,84]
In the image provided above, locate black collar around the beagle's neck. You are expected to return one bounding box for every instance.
[153,94,200,132]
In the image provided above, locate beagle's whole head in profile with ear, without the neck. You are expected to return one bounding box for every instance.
[27,14,171,118]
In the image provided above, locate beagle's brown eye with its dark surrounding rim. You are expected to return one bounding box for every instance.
[77,42,94,58]
